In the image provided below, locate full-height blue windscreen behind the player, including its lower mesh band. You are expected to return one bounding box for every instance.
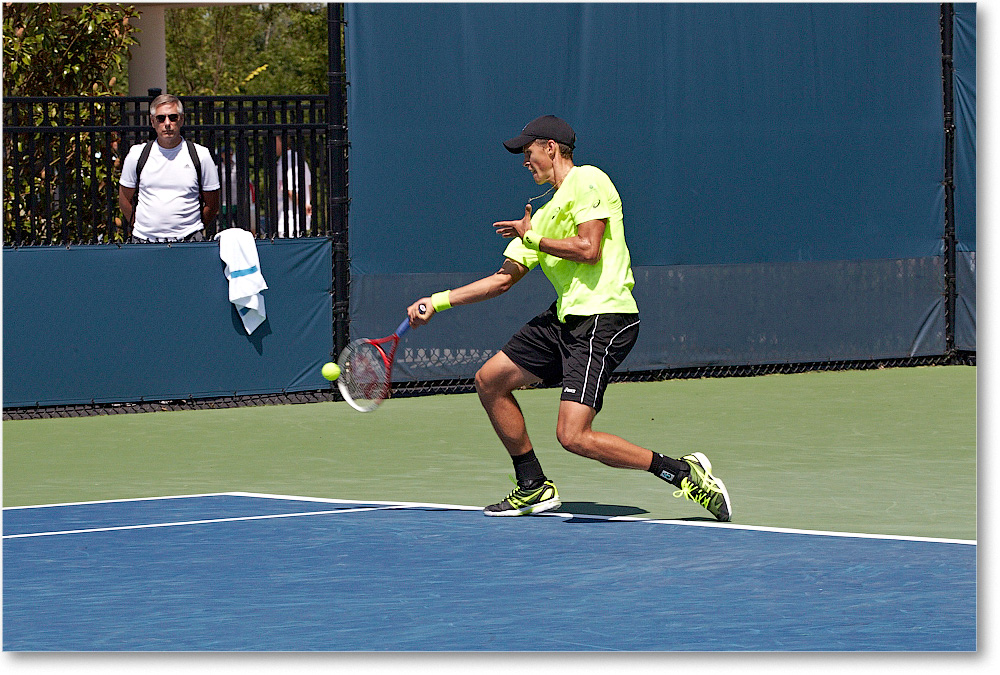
[346,3,975,379]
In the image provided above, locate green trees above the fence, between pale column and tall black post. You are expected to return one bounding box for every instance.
[166,3,327,96]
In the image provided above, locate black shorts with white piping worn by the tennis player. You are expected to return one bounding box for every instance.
[503,303,639,412]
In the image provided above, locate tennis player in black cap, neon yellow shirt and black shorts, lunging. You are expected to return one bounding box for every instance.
[407,115,732,521]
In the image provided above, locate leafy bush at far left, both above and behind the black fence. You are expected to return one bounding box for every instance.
[3,3,138,244]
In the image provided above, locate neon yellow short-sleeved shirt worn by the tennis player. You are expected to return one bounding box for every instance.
[504,166,639,322]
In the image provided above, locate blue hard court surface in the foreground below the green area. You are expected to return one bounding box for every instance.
[3,494,976,651]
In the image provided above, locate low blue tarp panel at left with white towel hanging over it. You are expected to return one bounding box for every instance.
[3,238,333,407]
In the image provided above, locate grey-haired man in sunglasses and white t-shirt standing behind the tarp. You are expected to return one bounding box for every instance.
[118,94,220,242]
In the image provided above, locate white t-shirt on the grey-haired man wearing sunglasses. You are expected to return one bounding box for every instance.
[120,140,220,240]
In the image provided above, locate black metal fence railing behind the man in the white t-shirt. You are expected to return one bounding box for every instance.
[3,96,346,246]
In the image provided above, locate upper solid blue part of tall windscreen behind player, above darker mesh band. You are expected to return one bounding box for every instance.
[347,3,948,273]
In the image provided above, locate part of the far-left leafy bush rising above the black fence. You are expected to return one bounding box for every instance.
[3,2,138,96]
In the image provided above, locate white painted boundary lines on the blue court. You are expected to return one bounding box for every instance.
[3,492,977,546]
